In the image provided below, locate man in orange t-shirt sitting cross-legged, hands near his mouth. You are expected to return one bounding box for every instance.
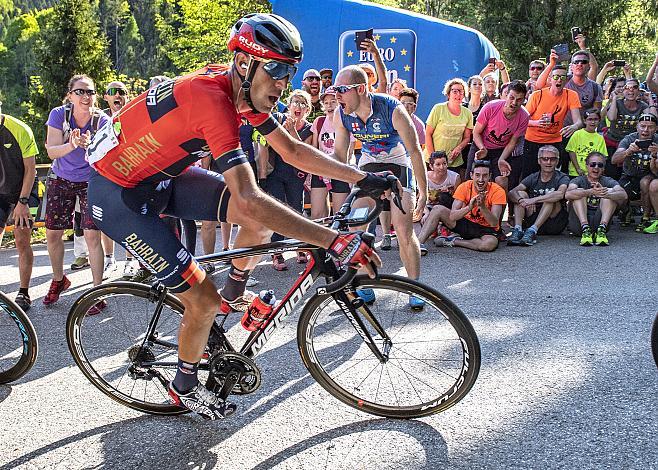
[422,160,507,251]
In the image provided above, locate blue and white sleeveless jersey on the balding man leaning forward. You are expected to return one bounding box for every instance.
[338,93,404,168]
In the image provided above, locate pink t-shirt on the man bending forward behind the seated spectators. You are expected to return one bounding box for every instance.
[477,100,530,150]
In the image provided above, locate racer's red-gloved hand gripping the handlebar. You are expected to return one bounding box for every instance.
[328,231,382,278]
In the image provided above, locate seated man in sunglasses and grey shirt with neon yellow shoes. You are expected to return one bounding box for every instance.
[565,152,627,246]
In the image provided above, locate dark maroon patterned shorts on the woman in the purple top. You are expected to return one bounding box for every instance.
[46,174,98,230]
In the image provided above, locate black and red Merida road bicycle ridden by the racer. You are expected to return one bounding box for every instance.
[66,177,480,418]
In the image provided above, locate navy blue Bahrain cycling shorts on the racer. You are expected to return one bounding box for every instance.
[89,167,230,292]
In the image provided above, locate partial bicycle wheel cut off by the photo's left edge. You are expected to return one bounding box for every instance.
[0,292,39,384]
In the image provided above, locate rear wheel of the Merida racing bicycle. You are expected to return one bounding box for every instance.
[66,282,189,415]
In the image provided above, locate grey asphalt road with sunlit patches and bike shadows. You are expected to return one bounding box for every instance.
[0,228,658,469]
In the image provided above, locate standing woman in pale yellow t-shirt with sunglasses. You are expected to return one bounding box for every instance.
[425,78,473,173]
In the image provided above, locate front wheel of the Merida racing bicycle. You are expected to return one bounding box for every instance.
[297,275,480,419]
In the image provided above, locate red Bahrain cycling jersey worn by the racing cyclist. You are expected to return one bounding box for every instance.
[90,65,269,188]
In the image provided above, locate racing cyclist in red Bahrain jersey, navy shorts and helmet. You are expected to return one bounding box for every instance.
[88,14,387,419]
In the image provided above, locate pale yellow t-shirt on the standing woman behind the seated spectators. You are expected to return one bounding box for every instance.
[426,103,473,168]
